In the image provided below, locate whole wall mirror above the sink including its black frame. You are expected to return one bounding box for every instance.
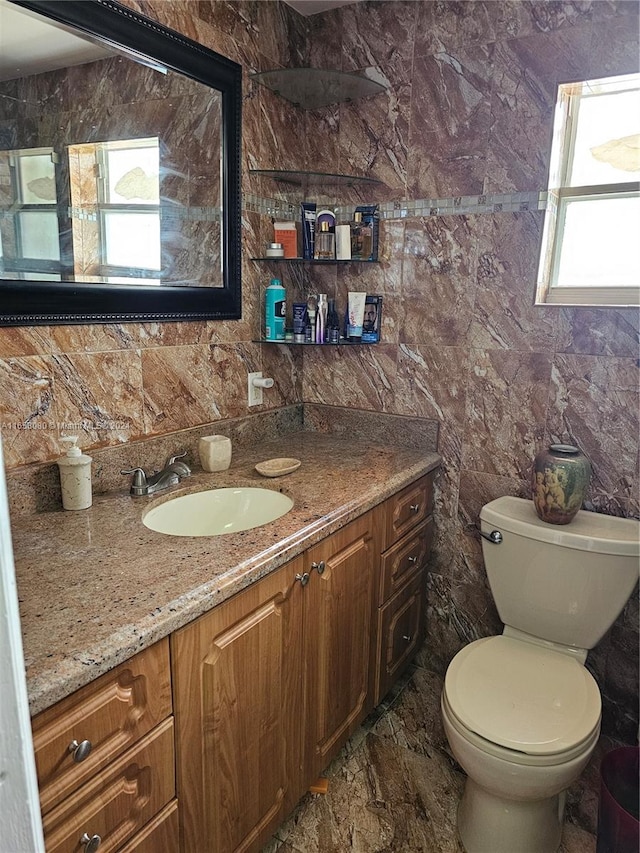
[0,0,242,325]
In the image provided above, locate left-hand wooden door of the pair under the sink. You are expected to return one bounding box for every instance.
[171,558,304,853]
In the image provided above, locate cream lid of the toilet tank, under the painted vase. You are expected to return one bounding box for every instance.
[480,495,640,568]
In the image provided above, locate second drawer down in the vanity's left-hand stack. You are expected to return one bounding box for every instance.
[42,718,175,853]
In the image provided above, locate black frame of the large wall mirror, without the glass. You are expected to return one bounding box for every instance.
[0,0,242,326]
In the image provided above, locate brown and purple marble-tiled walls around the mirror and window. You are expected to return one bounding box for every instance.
[0,0,640,816]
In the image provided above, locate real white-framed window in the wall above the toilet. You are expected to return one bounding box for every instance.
[536,74,640,305]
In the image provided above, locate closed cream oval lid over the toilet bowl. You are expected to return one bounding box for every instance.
[445,636,601,755]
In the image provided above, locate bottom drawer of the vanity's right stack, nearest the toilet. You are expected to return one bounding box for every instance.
[375,572,425,704]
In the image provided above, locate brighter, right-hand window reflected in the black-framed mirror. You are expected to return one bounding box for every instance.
[69,137,161,283]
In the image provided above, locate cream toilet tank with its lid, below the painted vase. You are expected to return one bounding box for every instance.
[480,496,640,649]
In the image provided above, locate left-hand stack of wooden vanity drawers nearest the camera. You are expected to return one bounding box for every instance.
[32,640,178,853]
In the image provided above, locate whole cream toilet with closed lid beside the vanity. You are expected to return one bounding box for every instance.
[441,497,640,853]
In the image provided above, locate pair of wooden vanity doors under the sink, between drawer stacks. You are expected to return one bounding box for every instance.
[171,513,377,853]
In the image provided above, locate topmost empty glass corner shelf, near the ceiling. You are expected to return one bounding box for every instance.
[249,68,385,110]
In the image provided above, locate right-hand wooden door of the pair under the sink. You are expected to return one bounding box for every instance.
[304,513,377,780]
